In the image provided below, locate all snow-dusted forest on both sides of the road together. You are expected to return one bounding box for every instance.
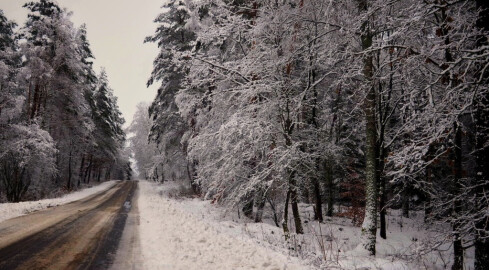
[0,0,489,270]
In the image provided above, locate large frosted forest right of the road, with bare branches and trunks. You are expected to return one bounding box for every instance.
[129,0,489,269]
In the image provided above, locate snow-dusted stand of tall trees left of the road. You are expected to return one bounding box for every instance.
[0,1,130,202]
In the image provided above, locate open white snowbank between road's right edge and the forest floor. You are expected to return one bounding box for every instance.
[138,181,308,270]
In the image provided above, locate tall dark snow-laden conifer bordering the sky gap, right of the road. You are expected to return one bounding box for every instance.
[146,0,195,185]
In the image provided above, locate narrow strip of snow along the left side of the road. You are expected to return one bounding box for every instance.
[0,180,117,222]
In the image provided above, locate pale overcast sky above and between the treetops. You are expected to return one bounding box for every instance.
[0,0,165,126]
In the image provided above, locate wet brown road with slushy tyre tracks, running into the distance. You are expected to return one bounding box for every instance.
[0,181,137,270]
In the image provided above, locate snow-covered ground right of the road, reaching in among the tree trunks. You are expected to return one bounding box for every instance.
[139,181,472,270]
